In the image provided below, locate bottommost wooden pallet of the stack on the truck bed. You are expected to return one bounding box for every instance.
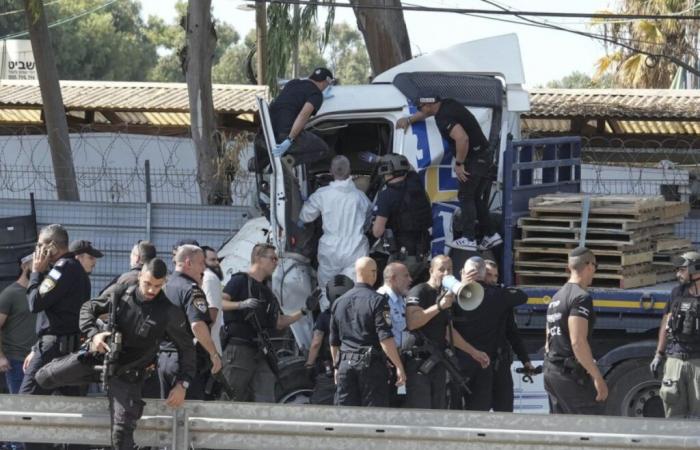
[515,270,656,289]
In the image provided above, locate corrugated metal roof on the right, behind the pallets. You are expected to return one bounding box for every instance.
[525,89,700,120]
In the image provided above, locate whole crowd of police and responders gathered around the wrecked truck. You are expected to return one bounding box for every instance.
[0,64,700,448]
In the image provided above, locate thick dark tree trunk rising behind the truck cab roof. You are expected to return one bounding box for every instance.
[350,0,412,77]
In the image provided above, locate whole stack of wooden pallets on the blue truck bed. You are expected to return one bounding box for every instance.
[515,194,689,289]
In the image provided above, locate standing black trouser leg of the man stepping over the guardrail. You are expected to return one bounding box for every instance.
[108,377,146,450]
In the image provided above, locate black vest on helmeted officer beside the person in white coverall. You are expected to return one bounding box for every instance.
[388,172,433,233]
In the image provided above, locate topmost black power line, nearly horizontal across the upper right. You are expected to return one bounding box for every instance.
[256,0,700,20]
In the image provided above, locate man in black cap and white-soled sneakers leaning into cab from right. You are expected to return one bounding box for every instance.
[396,93,503,251]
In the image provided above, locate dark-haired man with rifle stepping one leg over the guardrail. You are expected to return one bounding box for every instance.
[37,259,195,450]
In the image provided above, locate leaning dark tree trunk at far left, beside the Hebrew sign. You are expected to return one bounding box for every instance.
[24,0,80,201]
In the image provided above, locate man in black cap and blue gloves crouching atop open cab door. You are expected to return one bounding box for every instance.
[270,67,333,164]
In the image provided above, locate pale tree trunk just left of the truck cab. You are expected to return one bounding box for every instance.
[184,0,231,204]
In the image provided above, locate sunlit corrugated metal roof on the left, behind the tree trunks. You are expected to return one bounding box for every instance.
[0,80,268,114]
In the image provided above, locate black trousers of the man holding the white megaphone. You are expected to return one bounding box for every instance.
[404,356,447,409]
